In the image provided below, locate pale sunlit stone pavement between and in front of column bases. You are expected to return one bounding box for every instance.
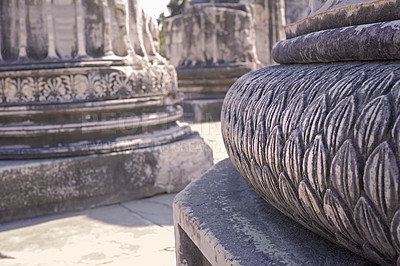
[0,122,227,266]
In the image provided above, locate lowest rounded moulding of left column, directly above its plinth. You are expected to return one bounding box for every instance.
[0,121,192,160]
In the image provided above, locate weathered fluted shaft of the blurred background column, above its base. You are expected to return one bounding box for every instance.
[166,0,284,67]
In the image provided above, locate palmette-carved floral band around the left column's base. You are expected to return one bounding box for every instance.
[0,61,177,106]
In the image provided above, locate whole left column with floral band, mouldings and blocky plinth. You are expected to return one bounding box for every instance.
[0,0,212,222]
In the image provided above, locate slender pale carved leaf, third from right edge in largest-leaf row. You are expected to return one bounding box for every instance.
[303,135,329,200]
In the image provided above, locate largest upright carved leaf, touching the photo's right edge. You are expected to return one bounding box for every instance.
[363,141,399,221]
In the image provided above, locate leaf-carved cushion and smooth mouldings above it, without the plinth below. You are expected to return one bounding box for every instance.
[221,0,400,265]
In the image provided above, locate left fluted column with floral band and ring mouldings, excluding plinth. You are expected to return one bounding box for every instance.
[0,0,184,159]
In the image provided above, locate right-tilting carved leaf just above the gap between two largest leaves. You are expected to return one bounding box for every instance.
[354,96,391,156]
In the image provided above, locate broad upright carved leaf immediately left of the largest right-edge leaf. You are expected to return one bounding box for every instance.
[330,140,361,208]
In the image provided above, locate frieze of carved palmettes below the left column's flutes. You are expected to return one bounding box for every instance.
[0,66,176,103]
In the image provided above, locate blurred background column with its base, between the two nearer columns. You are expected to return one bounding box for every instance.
[165,0,284,122]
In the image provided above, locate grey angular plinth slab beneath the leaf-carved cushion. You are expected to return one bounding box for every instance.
[173,159,371,266]
